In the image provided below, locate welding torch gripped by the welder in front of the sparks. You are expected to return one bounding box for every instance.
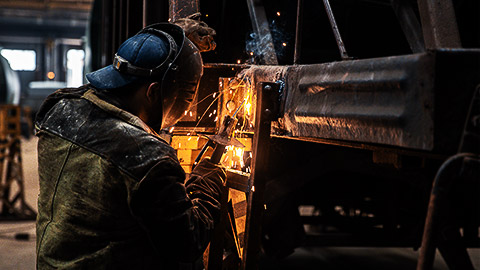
[192,100,245,170]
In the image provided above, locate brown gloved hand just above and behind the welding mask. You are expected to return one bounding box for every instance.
[173,13,216,52]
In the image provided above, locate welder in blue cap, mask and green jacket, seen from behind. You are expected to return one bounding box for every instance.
[35,23,225,269]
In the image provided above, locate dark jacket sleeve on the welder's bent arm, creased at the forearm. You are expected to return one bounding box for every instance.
[130,158,226,262]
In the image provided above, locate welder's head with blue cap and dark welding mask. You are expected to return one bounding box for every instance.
[86,23,203,128]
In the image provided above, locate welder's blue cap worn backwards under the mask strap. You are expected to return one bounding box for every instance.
[86,33,170,89]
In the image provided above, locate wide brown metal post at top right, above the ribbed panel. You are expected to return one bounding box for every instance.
[418,0,462,49]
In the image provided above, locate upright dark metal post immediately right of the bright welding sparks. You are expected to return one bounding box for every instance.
[242,83,278,269]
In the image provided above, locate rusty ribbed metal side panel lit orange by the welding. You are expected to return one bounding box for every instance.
[274,54,433,150]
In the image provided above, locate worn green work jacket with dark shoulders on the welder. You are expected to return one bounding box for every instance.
[35,85,225,269]
